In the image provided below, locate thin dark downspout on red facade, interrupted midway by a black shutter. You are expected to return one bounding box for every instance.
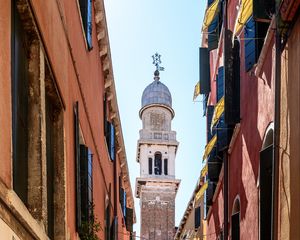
[223,0,229,240]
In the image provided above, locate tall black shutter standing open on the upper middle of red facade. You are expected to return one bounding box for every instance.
[224,31,240,124]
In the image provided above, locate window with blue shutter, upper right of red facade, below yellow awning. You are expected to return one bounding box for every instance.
[244,17,269,72]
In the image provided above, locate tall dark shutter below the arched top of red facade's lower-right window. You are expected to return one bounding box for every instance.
[259,145,273,240]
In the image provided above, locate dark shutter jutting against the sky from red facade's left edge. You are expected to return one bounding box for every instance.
[199,48,210,94]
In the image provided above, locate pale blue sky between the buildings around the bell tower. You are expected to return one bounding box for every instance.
[104,0,206,236]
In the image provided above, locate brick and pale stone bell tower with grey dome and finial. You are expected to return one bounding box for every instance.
[136,53,180,240]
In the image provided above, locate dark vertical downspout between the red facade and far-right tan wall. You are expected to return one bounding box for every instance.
[271,0,281,240]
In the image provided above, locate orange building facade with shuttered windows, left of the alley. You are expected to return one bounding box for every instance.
[0,0,135,239]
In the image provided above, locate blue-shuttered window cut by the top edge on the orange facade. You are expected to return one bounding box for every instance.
[79,0,93,50]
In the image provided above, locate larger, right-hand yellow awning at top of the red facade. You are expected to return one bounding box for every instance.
[233,0,253,35]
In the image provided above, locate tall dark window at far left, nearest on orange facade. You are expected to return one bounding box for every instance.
[12,0,29,204]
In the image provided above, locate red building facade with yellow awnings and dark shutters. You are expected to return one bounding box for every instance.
[200,0,275,239]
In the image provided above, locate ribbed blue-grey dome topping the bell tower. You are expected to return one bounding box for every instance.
[142,80,172,108]
